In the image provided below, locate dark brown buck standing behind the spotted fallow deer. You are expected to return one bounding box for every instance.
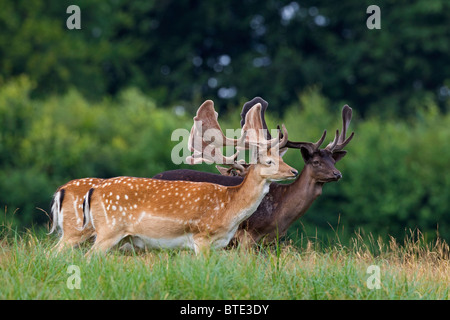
[155,98,354,246]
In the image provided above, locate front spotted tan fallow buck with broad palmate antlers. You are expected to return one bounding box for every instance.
[84,100,298,255]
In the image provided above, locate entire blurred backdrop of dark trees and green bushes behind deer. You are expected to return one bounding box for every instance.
[0,0,450,240]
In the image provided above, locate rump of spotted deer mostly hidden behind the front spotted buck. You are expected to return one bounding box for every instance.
[49,178,103,252]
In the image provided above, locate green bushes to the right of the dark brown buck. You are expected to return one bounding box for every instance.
[285,89,450,240]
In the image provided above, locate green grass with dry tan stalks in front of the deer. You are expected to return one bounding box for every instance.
[0,227,450,300]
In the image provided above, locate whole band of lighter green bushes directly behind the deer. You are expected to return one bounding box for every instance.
[0,77,450,240]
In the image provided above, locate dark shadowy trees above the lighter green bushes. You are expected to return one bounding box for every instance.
[0,0,450,116]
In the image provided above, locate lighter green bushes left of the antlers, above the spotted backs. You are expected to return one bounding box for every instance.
[0,77,192,226]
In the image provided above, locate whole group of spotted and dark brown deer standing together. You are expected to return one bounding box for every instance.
[50,97,354,256]
